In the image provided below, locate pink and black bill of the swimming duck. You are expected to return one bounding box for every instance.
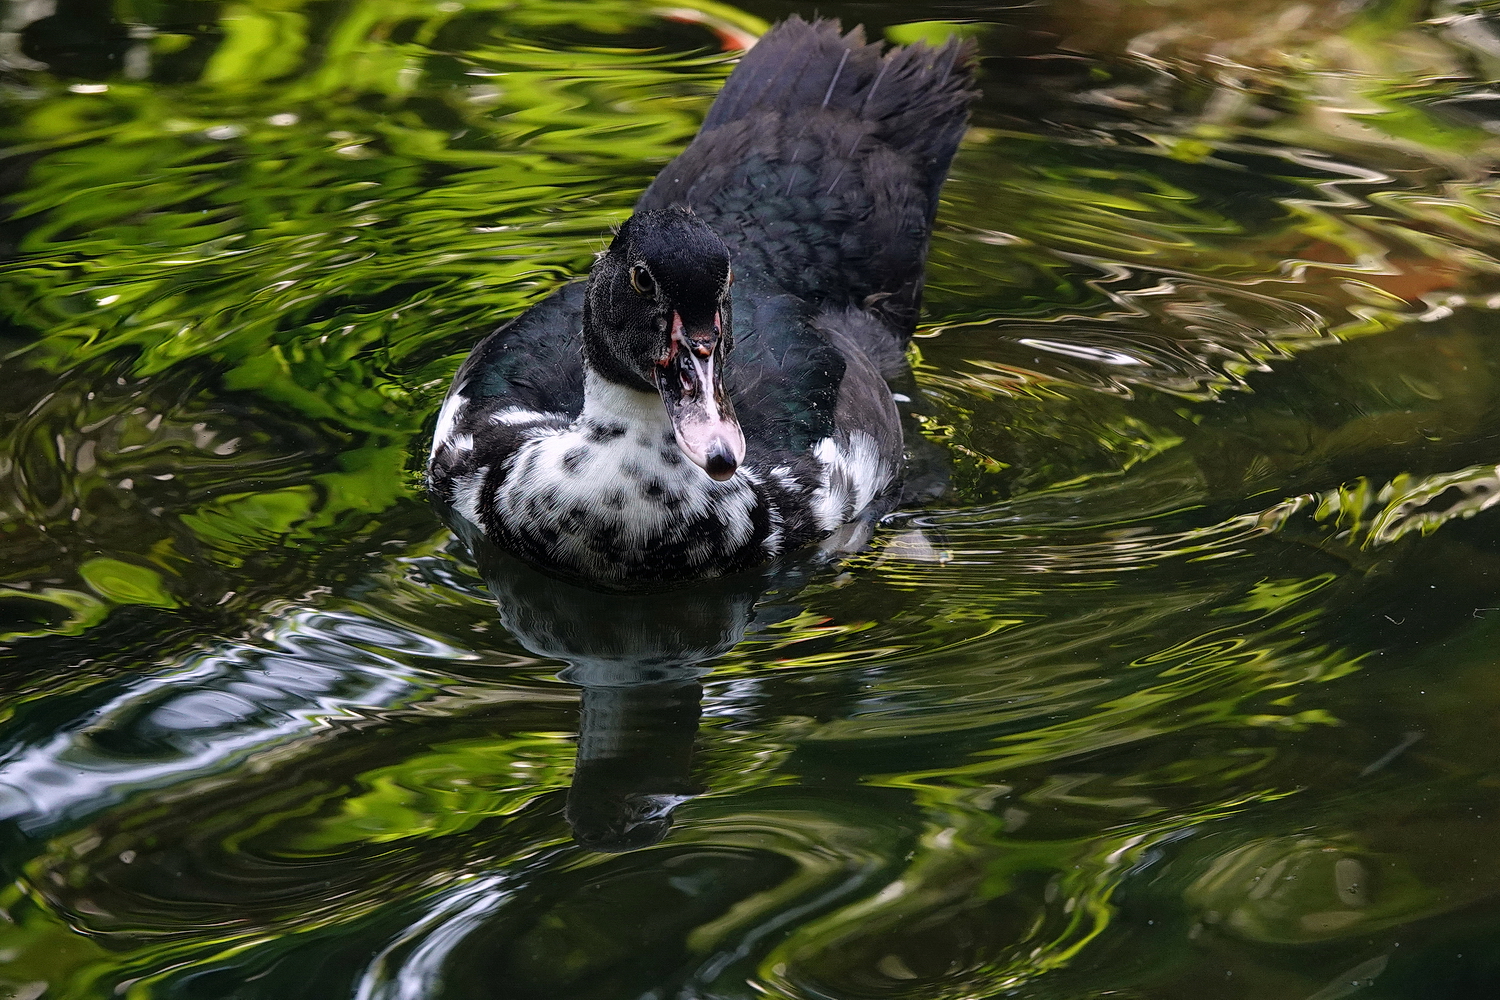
[657,312,746,483]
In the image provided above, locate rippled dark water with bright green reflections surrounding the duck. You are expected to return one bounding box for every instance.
[0,0,1500,1000]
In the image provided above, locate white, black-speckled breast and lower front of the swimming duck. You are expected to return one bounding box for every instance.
[434,372,897,583]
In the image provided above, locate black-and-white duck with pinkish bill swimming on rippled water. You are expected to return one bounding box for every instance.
[428,16,977,589]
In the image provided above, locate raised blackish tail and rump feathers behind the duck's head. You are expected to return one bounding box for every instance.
[638,16,974,342]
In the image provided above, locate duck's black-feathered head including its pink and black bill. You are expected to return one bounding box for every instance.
[584,208,746,480]
